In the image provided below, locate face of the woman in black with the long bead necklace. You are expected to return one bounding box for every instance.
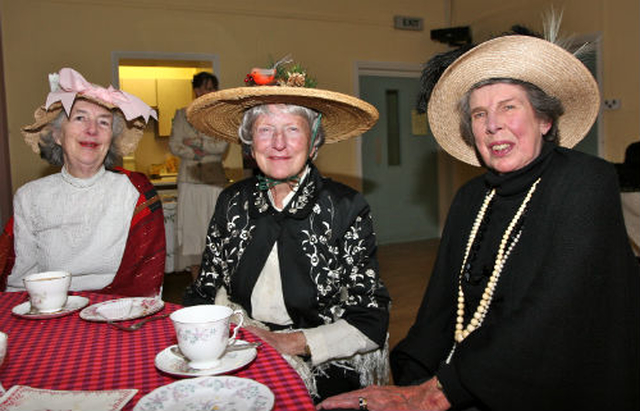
[469,83,551,173]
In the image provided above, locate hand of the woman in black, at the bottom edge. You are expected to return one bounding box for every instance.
[316,377,451,411]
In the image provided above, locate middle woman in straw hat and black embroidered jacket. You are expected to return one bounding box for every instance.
[180,64,389,400]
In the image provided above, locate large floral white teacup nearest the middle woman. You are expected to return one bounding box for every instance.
[169,304,244,370]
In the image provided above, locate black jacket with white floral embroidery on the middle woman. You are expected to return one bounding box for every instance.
[185,165,390,347]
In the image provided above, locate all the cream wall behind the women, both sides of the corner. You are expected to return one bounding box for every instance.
[0,0,640,225]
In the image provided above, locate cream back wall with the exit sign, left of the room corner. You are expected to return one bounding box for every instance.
[0,0,444,194]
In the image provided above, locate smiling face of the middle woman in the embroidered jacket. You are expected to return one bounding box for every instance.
[252,104,311,179]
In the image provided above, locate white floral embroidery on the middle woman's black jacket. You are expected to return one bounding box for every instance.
[197,171,383,323]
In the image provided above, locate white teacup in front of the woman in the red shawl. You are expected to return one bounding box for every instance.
[22,271,71,314]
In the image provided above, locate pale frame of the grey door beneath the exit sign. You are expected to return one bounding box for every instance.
[353,61,422,180]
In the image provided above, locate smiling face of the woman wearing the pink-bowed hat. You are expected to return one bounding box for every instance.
[53,100,113,178]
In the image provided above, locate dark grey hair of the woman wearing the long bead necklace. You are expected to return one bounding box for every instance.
[458,77,564,147]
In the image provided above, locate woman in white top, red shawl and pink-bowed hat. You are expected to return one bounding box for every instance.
[3,68,165,295]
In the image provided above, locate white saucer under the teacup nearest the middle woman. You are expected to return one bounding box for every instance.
[155,339,258,377]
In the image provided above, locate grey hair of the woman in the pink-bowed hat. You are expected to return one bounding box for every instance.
[38,109,126,169]
